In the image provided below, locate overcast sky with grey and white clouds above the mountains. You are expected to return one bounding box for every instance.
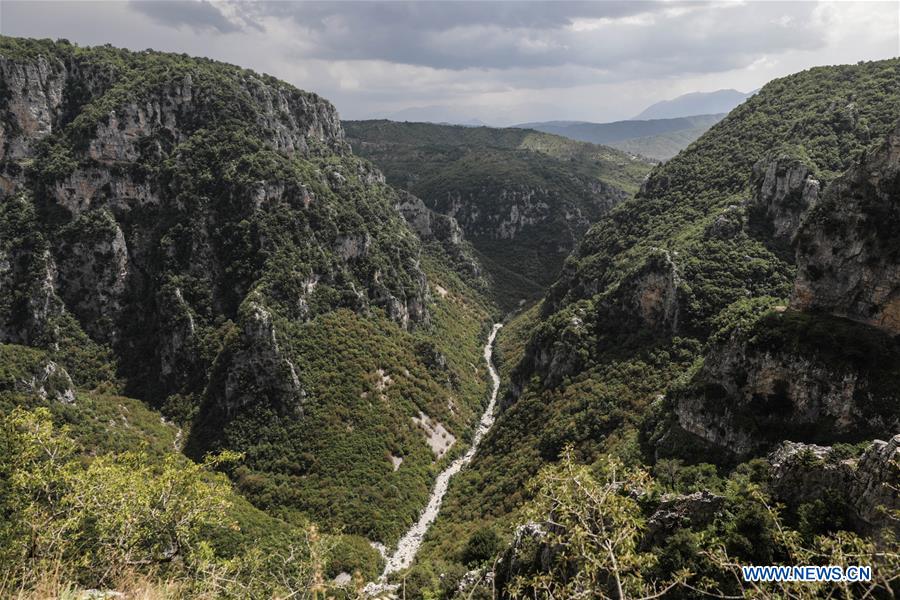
[0,0,900,125]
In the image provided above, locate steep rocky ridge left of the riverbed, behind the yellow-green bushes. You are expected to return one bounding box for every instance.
[0,38,490,542]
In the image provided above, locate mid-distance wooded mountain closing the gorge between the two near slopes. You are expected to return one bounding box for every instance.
[345,121,650,309]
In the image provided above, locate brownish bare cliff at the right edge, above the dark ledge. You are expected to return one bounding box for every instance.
[791,128,900,334]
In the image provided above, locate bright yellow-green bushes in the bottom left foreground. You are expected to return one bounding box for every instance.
[0,400,380,598]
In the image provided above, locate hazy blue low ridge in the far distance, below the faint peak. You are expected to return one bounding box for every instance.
[519,114,725,160]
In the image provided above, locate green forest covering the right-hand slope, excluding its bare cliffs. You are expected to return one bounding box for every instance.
[423,60,900,597]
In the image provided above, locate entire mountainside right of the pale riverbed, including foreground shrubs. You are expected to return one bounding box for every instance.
[423,59,900,598]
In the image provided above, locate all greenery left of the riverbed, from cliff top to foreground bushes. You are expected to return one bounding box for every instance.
[0,38,493,597]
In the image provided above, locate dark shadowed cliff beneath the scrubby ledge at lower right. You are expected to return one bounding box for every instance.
[670,313,900,458]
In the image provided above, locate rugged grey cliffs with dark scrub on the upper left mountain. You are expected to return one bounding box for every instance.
[0,40,428,406]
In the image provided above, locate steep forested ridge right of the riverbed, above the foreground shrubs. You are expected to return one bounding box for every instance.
[423,60,900,589]
